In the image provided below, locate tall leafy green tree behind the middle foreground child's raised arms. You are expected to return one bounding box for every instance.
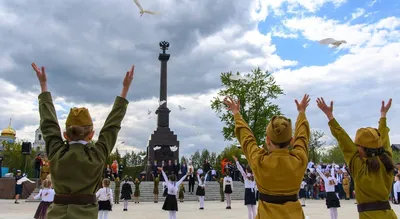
[211,68,283,145]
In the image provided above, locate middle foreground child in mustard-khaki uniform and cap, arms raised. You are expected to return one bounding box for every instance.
[224,94,310,219]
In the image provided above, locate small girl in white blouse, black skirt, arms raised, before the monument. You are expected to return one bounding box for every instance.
[158,167,187,219]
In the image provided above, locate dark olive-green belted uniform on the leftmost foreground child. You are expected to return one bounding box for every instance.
[39,92,128,219]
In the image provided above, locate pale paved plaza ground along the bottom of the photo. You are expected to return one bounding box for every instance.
[0,200,400,219]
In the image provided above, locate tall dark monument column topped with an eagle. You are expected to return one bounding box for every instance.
[147,41,179,170]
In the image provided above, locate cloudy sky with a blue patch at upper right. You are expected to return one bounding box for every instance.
[0,0,400,155]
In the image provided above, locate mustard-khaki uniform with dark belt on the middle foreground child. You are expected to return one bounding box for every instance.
[234,113,310,219]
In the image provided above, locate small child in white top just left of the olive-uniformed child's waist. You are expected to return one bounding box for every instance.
[34,179,55,219]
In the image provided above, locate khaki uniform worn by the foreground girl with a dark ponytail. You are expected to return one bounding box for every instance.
[329,118,397,219]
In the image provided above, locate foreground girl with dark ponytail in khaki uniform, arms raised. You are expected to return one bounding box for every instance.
[317,98,397,219]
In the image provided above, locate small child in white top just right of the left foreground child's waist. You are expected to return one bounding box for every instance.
[96,178,114,219]
